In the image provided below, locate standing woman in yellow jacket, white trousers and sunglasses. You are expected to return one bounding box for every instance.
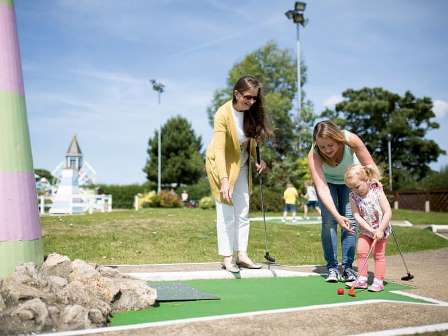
[206,76,271,273]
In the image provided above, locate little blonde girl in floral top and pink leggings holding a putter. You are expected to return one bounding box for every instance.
[345,165,392,292]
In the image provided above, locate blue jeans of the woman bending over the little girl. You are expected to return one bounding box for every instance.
[319,183,357,270]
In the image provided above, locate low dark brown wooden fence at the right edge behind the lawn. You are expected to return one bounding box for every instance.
[389,189,448,212]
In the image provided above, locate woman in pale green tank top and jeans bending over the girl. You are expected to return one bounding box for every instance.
[308,120,375,282]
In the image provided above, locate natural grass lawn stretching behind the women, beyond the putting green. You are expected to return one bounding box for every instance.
[41,209,448,265]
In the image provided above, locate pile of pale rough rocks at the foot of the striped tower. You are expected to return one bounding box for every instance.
[0,253,156,336]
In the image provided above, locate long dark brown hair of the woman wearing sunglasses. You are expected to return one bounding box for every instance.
[232,75,272,140]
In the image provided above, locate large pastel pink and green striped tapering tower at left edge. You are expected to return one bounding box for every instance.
[0,0,43,278]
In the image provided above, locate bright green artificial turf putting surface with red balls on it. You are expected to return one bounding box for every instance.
[111,276,425,326]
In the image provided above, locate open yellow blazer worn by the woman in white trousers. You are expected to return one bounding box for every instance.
[205,101,257,203]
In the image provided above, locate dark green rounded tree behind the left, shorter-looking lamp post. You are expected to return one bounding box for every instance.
[143,116,204,186]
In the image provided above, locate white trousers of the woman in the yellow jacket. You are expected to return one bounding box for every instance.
[216,165,249,256]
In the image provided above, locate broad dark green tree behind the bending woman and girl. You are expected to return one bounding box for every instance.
[322,88,445,189]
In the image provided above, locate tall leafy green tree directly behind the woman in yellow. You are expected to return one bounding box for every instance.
[207,41,315,190]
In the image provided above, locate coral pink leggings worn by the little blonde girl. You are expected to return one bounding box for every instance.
[358,235,387,280]
